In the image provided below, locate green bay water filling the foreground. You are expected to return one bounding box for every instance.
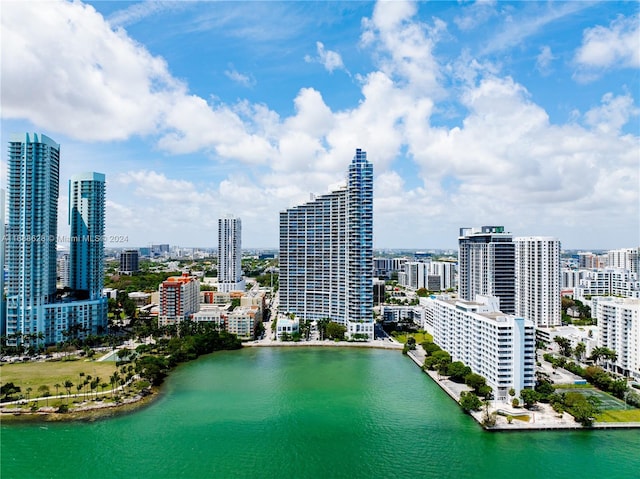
[0,348,640,479]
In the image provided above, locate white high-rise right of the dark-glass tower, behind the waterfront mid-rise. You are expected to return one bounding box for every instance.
[513,236,562,328]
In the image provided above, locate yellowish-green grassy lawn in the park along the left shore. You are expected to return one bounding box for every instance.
[0,359,116,397]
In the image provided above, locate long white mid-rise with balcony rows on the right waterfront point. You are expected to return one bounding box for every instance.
[421,295,536,401]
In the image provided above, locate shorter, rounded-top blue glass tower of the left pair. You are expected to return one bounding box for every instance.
[69,173,105,299]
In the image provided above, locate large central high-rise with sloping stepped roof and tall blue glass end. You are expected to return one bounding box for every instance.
[279,149,373,339]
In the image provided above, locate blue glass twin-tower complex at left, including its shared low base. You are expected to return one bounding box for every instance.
[5,133,107,346]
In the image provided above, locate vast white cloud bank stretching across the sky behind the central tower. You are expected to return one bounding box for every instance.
[0,2,640,246]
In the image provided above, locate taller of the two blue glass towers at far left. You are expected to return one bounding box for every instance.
[6,133,60,344]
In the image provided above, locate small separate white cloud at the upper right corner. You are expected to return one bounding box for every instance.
[574,15,640,81]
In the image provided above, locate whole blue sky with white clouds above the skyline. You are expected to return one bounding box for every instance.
[0,1,640,250]
